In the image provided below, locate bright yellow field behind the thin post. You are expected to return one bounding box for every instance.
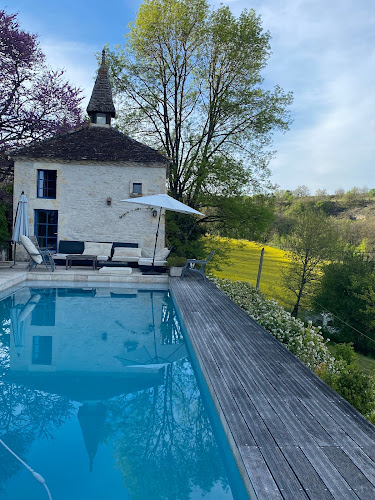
[213,239,294,310]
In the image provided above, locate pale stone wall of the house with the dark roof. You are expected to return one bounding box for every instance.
[14,160,166,258]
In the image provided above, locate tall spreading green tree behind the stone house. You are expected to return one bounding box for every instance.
[109,0,292,208]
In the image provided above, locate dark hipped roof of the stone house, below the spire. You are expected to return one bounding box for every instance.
[11,125,168,163]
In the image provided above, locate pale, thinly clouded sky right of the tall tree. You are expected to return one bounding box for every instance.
[215,0,375,192]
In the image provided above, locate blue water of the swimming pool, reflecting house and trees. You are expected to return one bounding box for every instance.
[0,284,248,500]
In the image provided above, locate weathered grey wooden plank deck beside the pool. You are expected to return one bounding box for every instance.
[170,277,375,500]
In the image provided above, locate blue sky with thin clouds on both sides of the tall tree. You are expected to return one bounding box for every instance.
[0,0,375,193]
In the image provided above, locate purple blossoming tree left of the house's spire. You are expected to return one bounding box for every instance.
[0,10,84,162]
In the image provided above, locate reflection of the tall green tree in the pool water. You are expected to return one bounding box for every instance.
[106,359,227,499]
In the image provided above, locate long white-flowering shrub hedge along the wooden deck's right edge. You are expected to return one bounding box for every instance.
[210,276,341,372]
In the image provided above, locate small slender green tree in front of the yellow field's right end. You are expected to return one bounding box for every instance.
[283,203,339,317]
